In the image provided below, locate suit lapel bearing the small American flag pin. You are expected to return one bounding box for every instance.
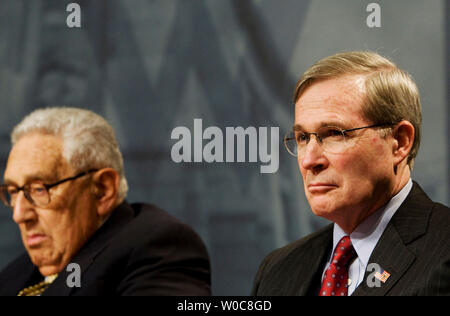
[353,182,433,296]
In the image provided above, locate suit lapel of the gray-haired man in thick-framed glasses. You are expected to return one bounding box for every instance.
[44,202,134,296]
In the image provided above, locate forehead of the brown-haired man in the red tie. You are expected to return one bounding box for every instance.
[295,75,366,129]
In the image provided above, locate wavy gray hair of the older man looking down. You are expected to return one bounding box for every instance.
[11,107,128,200]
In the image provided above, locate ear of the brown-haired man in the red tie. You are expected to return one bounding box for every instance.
[392,120,415,168]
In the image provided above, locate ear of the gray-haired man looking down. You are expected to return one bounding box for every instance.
[92,168,120,217]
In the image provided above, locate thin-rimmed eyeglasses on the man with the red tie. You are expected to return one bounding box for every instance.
[283,123,394,157]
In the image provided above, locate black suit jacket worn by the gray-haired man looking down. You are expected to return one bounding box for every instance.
[0,202,211,296]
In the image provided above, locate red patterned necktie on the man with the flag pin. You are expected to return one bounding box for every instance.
[319,236,356,296]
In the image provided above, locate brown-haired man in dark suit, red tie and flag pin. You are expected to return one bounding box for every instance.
[252,52,450,296]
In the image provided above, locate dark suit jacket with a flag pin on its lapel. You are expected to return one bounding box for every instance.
[252,183,450,296]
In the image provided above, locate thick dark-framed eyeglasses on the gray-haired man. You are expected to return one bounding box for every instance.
[0,169,98,208]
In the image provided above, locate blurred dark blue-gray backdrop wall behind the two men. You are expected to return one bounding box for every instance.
[0,0,450,295]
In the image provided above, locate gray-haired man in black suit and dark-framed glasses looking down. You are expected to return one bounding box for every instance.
[0,108,211,296]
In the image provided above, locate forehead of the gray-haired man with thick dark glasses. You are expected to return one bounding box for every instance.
[4,133,68,186]
